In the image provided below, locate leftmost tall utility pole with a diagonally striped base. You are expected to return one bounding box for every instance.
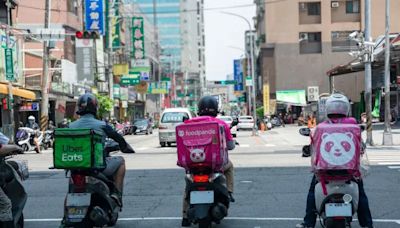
[40,0,51,131]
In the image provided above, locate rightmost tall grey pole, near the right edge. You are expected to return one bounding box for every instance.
[383,0,393,145]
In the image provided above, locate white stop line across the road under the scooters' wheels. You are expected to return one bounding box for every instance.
[24,217,400,224]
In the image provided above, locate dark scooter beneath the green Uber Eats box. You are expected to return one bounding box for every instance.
[61,141,122,228]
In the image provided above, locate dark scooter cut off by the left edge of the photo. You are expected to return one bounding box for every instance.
[0,145,29,228]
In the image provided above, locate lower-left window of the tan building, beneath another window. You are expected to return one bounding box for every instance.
[299,32,322,54]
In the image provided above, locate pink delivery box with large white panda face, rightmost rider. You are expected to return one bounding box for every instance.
[311,119,362,179]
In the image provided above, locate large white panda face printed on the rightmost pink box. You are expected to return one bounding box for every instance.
[320,132,356,166]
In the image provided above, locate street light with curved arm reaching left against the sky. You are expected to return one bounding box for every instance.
[221,11,257,136]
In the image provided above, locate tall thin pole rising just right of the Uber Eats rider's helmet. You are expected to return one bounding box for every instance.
[108,0,114,118]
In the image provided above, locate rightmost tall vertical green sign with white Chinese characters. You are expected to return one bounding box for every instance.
[132,17,146,59]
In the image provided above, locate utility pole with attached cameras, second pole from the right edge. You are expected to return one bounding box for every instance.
[364,0,374,146]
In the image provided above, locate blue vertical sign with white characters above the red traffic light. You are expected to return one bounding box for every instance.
[85,0,105,35]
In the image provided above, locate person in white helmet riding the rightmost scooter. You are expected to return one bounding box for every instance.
[296,93,373,228]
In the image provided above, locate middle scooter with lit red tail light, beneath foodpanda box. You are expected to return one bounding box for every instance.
[185,165,230,228]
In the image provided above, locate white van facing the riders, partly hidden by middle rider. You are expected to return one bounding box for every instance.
[158,108,196,147]
